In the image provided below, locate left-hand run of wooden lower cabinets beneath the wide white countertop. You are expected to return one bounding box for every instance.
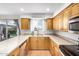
[9,40,30,56]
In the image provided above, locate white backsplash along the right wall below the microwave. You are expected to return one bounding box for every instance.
[55,31,79,40]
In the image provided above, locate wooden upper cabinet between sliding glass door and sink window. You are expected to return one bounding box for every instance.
[21,18,30,30]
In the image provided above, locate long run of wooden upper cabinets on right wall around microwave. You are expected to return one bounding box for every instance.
[53,3,79,32]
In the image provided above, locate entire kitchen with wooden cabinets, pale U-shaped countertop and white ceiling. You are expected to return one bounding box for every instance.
[0,3,79,56]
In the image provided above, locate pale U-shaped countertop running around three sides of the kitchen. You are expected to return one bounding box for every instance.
[0,35,76,56]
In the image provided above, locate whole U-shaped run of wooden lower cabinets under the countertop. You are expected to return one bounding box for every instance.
[9,37,64,56]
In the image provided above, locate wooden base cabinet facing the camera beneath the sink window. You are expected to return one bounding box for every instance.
[29,37,49,49]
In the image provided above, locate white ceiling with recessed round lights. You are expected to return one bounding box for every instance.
[0,3,68,18]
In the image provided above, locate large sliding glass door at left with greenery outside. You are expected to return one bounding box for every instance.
[0,19,19,41]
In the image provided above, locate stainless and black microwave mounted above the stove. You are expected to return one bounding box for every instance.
[68,16,79,34]
